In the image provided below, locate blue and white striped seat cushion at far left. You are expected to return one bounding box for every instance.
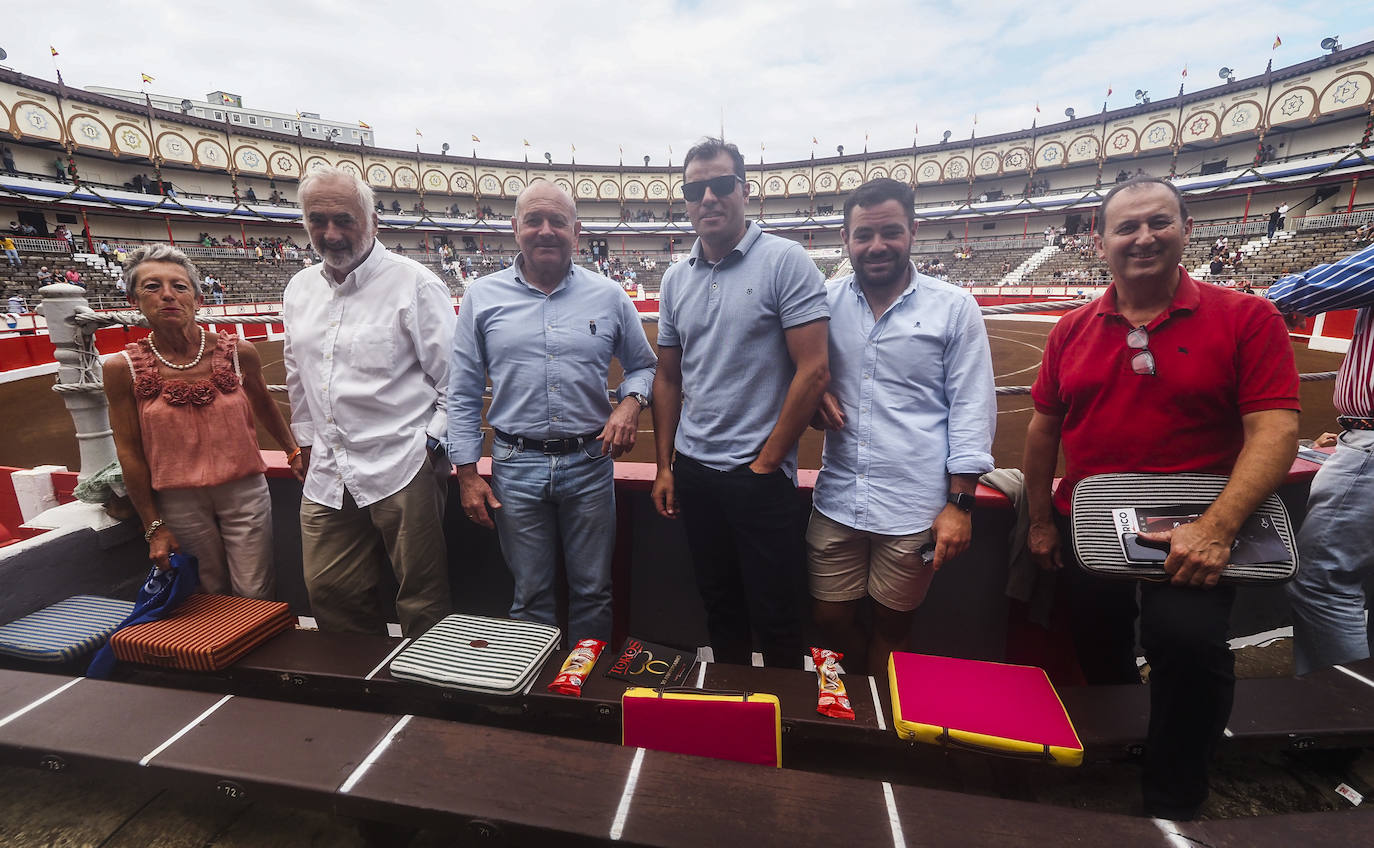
[0,595,133,662]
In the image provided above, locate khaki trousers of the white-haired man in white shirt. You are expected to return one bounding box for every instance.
[301,462,453,636]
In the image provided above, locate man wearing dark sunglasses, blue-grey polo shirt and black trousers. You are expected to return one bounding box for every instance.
[653,139,830,668]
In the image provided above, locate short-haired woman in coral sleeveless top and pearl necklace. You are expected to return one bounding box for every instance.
[104,245,304,598]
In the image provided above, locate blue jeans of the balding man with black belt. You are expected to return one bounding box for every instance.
[492,437,616,645]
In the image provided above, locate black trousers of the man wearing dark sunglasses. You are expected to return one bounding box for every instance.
[673,454,805,668]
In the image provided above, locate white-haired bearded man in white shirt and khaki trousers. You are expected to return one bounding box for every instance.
[283,169,455,636]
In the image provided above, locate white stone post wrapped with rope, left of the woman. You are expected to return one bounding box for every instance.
[38,283,115,480]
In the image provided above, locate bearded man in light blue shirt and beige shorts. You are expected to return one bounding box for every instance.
[807,179,998,676]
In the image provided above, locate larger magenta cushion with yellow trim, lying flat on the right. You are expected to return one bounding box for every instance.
[888,651,1083,766]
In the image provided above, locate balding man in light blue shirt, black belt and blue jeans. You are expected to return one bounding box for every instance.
[448,181,657,643]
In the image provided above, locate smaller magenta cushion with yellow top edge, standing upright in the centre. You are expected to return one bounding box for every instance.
[621,687,782,768]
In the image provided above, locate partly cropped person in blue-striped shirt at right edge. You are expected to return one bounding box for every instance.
[1268,246,1374,675]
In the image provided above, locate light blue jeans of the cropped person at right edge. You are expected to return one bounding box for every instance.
[1287,430,1374,675]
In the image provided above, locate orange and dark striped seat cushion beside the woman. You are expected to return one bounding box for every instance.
[110,594,295,671]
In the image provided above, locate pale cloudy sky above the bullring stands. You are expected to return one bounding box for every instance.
[10,0,1374,164]
